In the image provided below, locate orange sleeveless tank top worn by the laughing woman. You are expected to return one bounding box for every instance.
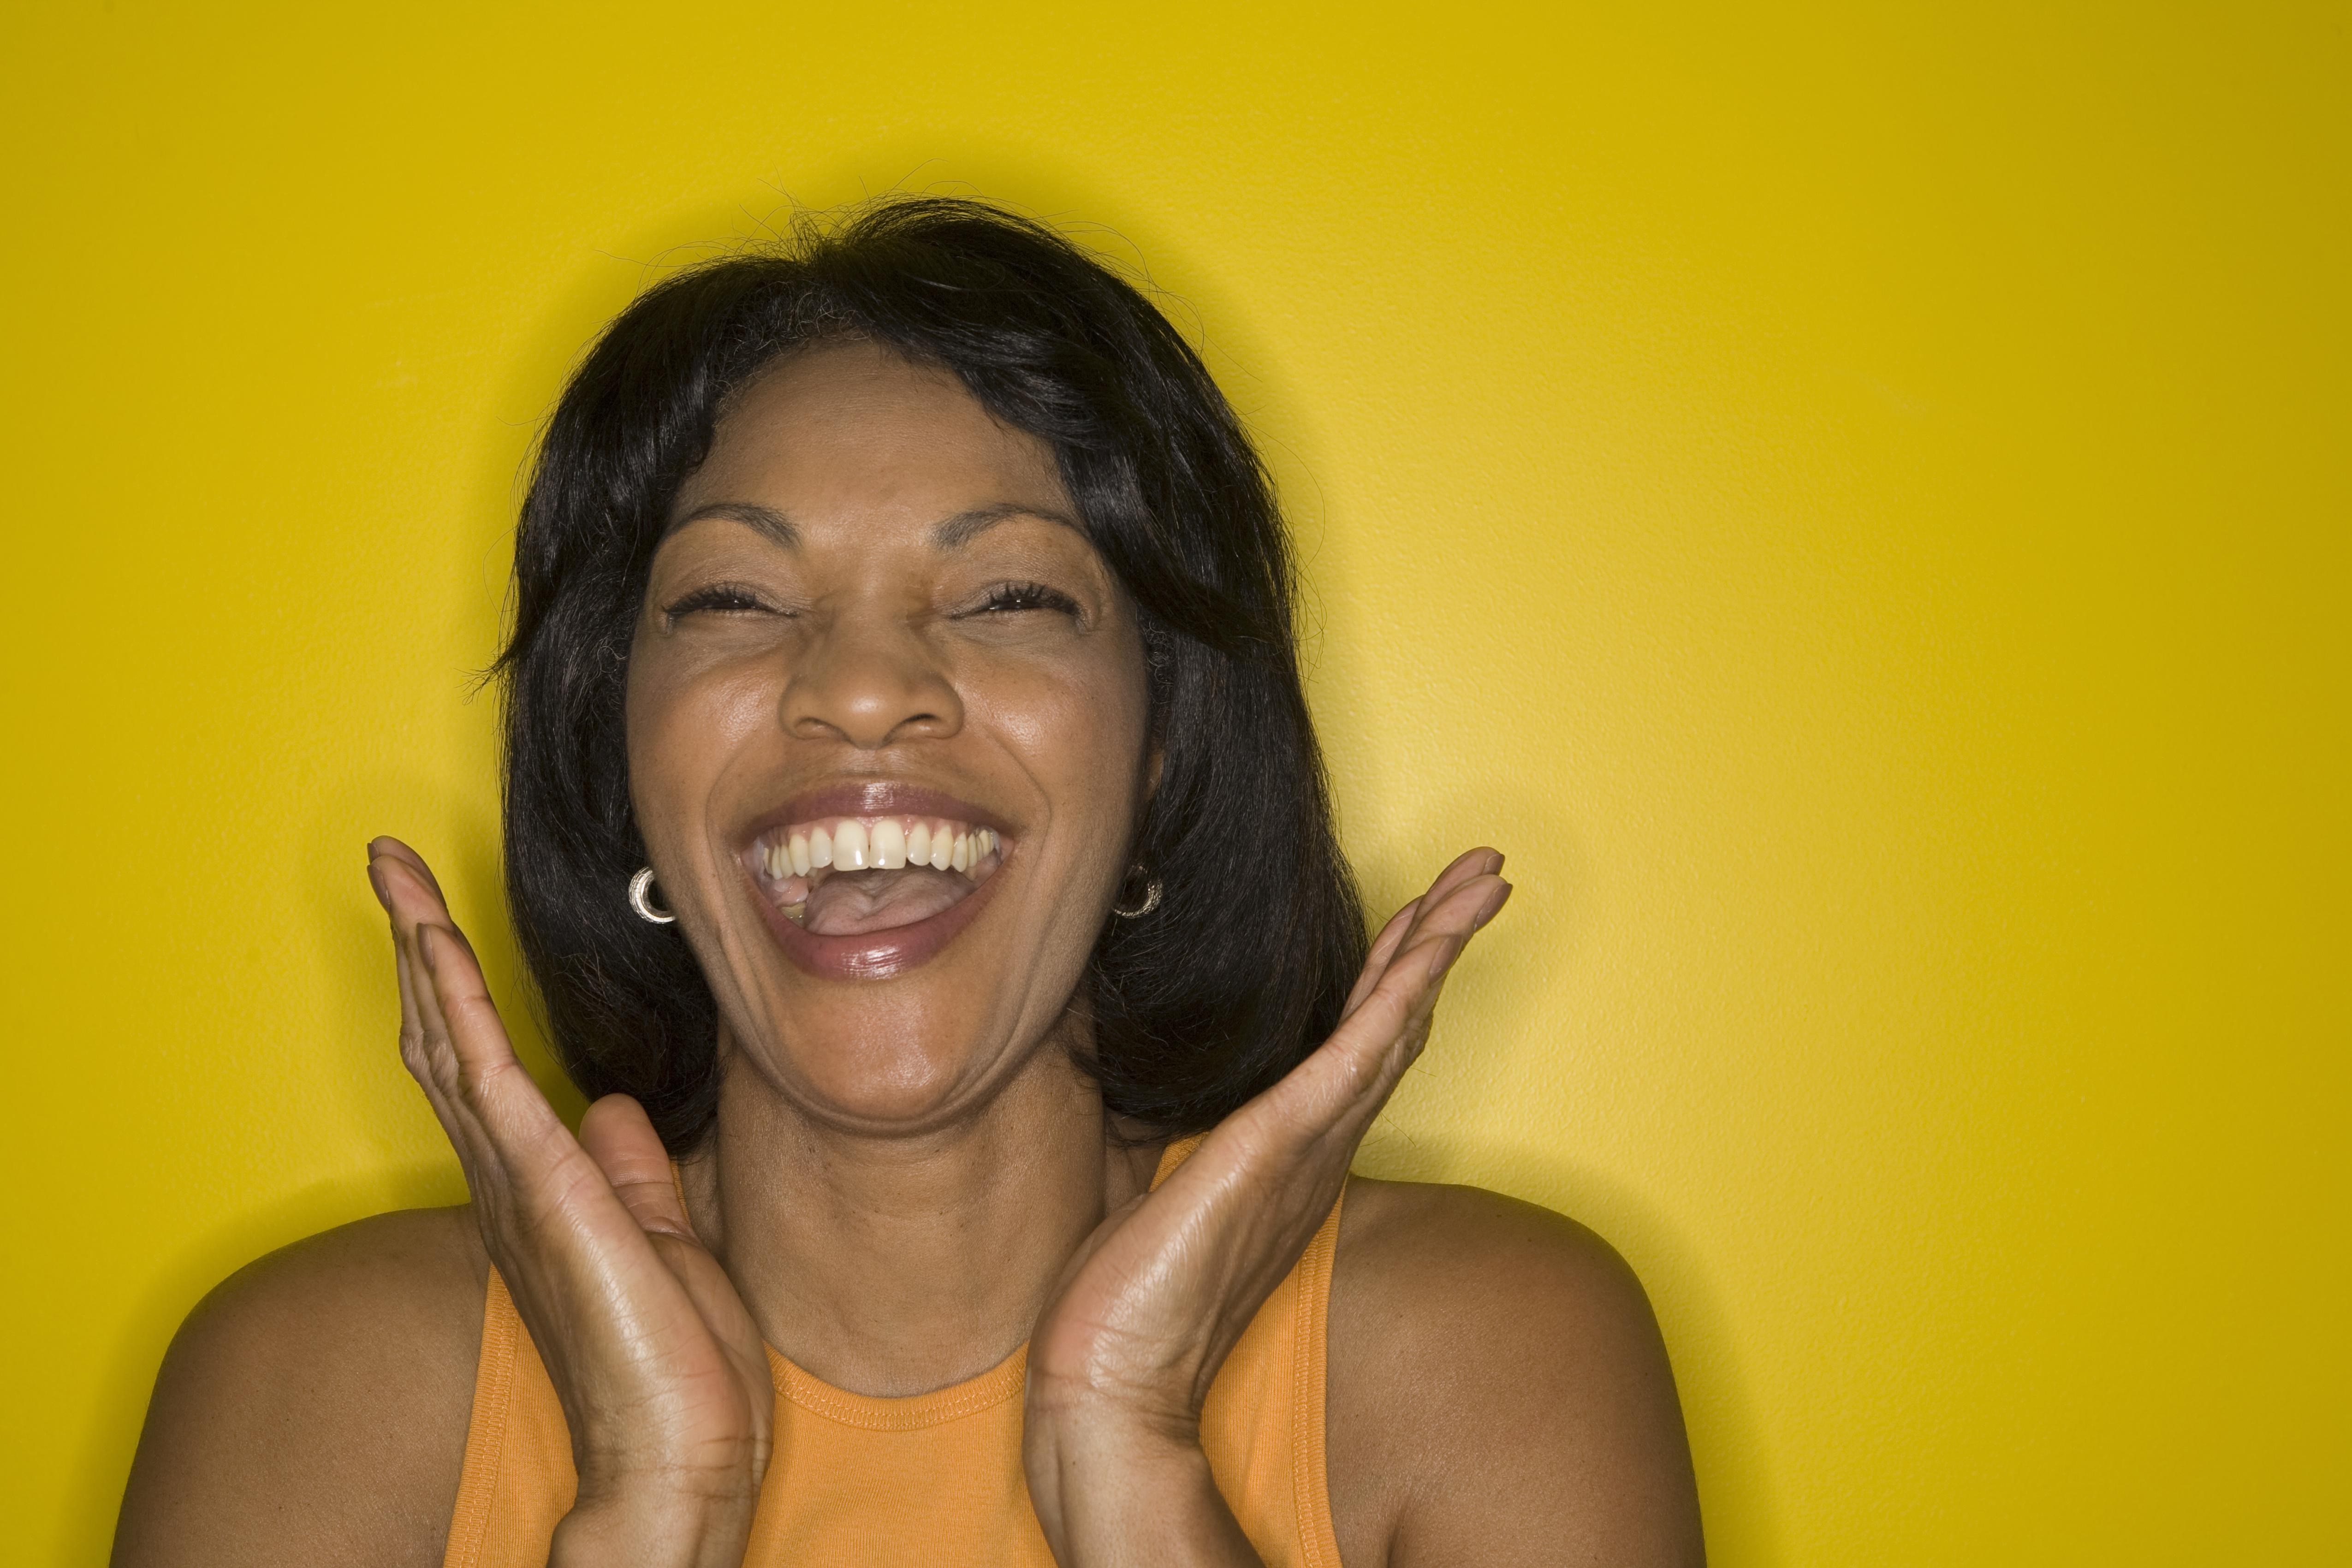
[442,1140,1338,1568]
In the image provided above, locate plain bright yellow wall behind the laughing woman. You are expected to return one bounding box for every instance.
[0,0,2352,1566]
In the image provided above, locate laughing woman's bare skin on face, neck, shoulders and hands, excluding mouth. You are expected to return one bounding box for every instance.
[115,343,1700,1568]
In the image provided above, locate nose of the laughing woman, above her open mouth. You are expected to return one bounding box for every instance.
[778,616,964,752]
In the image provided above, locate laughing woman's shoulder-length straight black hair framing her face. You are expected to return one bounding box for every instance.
[499,197,1364,1152]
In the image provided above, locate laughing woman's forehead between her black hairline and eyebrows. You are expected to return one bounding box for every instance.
[675,341,1068,520]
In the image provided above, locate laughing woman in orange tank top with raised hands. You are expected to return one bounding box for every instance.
[115,200,1700,1568]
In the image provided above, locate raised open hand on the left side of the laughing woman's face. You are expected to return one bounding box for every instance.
[367,839,774,1568]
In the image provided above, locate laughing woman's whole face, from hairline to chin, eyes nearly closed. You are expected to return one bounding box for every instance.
[628,343,1150,1126]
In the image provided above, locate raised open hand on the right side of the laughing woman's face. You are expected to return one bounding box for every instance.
[1023,849,1510,1568]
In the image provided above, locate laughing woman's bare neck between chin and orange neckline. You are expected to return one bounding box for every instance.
[682,1020,1157,1396]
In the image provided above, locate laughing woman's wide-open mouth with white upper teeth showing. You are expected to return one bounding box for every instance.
[743,814,1007,938]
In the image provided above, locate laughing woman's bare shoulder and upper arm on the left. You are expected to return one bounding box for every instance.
[113,1208,489,1568]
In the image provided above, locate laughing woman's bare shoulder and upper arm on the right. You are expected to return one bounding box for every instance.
[1326,1178,1703,1568]
